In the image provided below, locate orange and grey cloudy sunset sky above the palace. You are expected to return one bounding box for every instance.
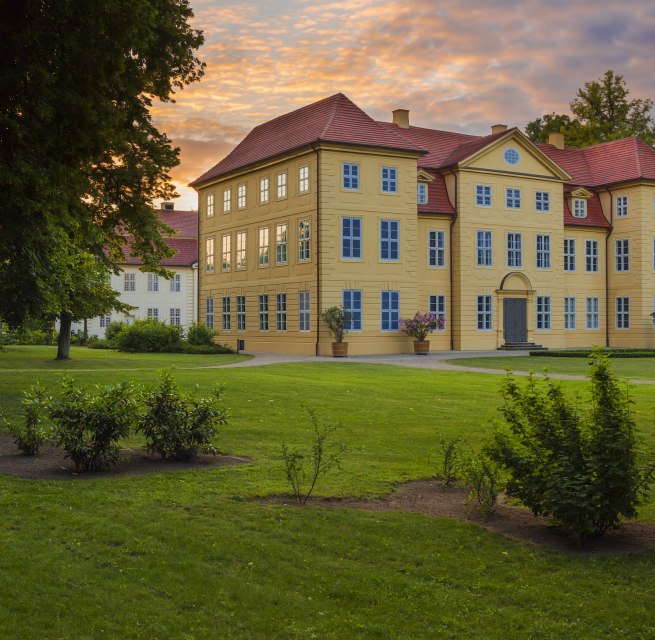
[153,0,655,209]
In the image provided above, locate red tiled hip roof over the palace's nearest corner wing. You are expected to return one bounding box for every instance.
[191,93,425,186]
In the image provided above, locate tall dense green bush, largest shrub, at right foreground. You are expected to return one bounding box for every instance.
[487,351,653,545]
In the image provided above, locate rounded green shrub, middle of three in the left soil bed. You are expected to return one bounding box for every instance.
[51,376,136,471]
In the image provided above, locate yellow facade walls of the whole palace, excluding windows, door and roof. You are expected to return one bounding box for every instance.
[197,137,655,355]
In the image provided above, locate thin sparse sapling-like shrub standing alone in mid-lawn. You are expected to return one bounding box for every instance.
[281,407,344,504]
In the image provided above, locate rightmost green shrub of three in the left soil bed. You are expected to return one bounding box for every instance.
[137,371,228,460]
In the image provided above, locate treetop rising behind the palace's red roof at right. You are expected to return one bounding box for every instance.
[525,69,655,147]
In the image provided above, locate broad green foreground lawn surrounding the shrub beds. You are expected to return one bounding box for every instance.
[0,348,655,640]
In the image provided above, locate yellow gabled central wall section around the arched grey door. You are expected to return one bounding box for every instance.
[453,141,564,350]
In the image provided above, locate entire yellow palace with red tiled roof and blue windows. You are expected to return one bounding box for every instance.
[192,94,655,355]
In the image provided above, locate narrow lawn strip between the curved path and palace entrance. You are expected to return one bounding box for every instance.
[447,356,655,380]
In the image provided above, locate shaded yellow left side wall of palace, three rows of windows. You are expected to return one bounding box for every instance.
[199,152,318,355]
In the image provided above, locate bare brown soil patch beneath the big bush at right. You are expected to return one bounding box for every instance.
[277,480,655,555]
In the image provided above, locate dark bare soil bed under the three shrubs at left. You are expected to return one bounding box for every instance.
[0,435,250,480]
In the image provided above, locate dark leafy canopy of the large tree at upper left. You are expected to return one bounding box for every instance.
[0,0,203,324]
